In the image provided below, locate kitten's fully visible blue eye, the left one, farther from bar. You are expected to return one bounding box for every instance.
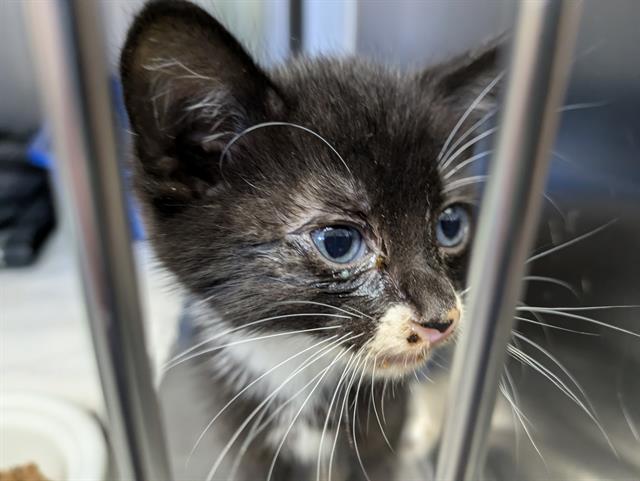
[311,225,366,264]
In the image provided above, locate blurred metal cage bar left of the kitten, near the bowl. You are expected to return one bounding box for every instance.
[25,0,170,481]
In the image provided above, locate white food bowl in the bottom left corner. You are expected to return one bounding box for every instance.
[0,393,107,481]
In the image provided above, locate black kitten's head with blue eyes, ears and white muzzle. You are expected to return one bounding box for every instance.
[121,2,496,376]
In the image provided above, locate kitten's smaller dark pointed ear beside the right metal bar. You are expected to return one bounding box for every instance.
[423,36,506,117]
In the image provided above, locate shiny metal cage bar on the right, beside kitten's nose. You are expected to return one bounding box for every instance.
[436,0,581,481]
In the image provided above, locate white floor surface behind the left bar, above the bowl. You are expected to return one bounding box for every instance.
[0,229,180,414]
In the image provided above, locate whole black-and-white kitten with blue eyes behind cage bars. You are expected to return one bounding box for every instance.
[121,1,497,480]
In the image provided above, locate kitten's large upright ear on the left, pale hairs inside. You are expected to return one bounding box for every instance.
[120,0,284,205]
